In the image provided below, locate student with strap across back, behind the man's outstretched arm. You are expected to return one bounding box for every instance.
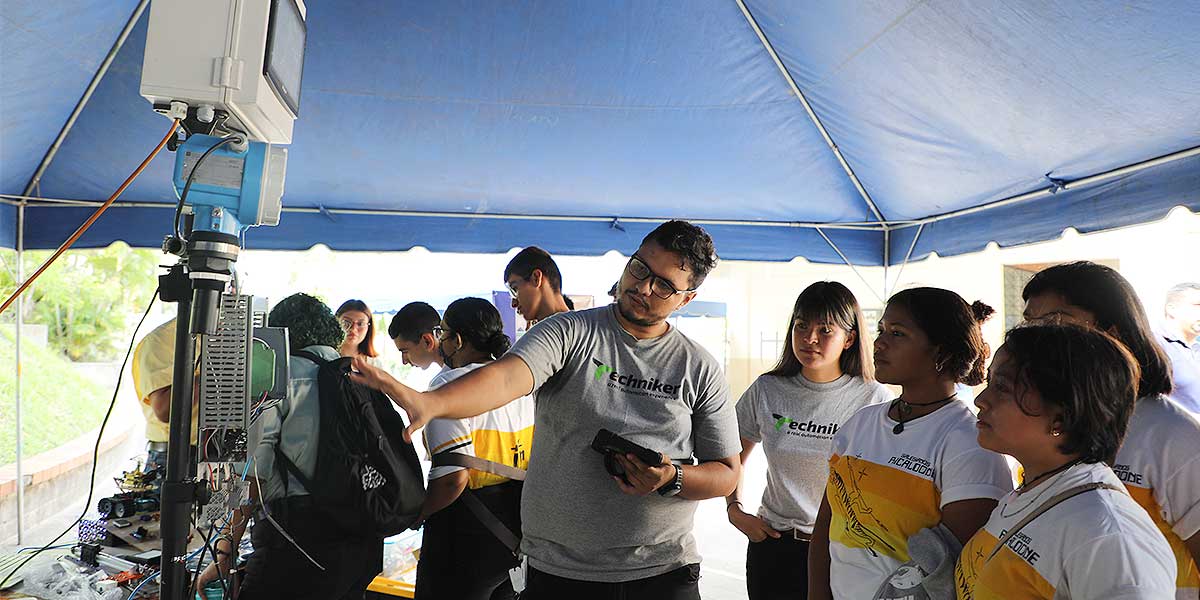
[415,298,534,600]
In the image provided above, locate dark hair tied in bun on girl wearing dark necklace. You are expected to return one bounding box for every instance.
[888,288,996,385]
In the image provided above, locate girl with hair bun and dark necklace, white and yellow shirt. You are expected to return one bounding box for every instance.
[808,288,1013,600]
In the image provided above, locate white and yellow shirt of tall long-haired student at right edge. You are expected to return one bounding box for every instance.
[1112,396,1200,600]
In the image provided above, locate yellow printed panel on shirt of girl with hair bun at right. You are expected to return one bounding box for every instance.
[826,454,942,563]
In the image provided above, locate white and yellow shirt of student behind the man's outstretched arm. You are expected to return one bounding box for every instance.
[425,362,534,490]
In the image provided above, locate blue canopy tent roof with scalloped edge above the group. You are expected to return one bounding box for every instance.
[0,0,1200,544]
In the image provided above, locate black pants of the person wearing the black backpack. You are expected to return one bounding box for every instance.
[238,497,383,600]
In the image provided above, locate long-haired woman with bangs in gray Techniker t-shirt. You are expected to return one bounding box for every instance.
[726,281,892,600]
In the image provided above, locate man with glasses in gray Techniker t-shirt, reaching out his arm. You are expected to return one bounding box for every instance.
[354,221,740,600]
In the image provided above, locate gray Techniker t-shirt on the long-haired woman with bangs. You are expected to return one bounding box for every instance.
[737,374,892,533]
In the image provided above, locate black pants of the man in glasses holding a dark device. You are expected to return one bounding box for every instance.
[521,563,700,600]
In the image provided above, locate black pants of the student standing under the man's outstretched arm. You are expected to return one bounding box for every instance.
[414,481,521,600]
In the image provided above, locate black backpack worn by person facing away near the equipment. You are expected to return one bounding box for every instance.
[275,350,425,538]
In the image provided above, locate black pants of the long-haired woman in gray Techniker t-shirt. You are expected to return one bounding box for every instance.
[746,534,809,600]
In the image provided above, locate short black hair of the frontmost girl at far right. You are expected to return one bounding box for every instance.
[1001,324,1140,464]
